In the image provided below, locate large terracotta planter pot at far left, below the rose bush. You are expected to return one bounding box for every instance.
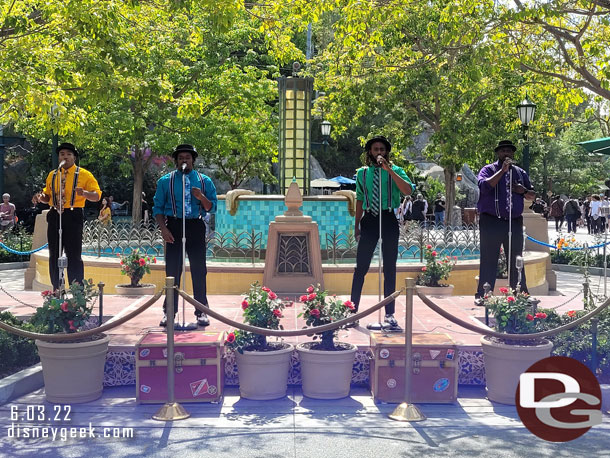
[36,336,110,404]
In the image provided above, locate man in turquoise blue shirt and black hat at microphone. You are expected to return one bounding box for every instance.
[153,144,217,326]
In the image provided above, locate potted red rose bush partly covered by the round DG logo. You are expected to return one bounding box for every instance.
[481,287,553,405]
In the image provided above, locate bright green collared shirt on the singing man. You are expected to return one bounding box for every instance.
[356,165,414,210]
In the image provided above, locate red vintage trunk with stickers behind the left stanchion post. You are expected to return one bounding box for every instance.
[136,331,224,403]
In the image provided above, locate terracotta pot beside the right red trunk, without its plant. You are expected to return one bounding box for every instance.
[297,343,357,399]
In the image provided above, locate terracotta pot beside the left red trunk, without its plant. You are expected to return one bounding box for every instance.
[235,344,294,401]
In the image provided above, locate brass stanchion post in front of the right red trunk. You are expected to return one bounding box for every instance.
[389,278,426,421]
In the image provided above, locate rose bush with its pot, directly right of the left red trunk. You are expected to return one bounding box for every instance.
[225,283,294,400]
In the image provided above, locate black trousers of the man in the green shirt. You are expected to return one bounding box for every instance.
[351,210,399,314]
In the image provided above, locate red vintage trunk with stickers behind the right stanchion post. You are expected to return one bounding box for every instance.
[370,333,458,403]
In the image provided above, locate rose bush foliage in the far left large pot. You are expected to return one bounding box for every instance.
[30,280,98,334]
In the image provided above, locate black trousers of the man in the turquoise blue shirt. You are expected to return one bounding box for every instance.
[163,217,208,316]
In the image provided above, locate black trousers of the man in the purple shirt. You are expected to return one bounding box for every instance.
[475,213,527,297]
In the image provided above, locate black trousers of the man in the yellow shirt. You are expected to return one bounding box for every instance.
[47,208,85,290]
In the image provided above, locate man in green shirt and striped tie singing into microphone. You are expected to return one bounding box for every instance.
[351,136,413,329]
